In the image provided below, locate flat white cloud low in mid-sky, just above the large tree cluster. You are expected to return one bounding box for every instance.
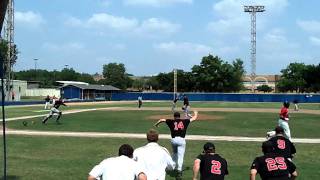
[154,42,212,55]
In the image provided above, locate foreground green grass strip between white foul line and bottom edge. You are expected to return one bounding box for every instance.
[1,136,320,180]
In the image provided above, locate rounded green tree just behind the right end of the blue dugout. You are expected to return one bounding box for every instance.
[103,63,133,89]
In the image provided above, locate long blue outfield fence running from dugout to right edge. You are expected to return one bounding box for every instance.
[111,92,320,103]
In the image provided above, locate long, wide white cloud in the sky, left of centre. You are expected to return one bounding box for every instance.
[65,13,181,36]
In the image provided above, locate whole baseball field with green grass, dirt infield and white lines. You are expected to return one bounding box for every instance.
[0,101,320,180]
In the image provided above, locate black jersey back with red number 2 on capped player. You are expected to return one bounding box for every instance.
[198,154,229,180]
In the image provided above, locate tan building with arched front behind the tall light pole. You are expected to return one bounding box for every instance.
[242,75,280,91]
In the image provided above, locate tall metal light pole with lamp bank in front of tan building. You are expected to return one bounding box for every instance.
[244,6,265,92]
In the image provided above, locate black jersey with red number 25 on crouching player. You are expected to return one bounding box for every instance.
[251,153,296,180]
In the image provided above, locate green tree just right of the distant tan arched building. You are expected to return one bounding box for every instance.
[277,63,307,92]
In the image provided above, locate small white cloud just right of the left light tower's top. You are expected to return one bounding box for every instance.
[14,11,45,28]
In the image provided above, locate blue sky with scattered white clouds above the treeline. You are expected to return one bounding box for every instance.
[14,0,320,76]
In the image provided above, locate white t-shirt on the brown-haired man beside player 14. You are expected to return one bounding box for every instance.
[133,142,175,180]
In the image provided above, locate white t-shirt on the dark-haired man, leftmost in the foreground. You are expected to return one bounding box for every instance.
[89,156,143,180]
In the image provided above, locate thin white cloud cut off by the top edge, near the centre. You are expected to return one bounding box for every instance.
[123,0,193,7]
